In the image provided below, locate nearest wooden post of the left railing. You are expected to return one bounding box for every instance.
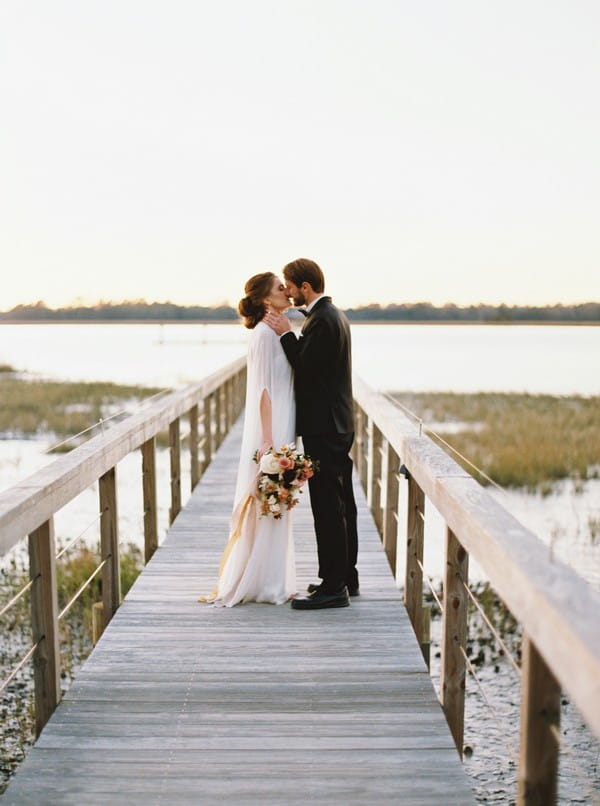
[29,518,61,736]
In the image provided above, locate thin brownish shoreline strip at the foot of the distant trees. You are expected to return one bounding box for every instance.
[0,317,600,327]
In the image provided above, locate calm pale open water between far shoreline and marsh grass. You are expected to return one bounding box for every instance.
[0,324,600,395]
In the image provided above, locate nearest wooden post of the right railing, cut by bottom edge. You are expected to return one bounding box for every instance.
[517,635,560,806]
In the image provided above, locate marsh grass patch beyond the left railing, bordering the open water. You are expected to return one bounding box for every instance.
[0,375,160,442]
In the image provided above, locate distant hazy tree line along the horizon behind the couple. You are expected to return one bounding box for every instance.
[0,300,600,322]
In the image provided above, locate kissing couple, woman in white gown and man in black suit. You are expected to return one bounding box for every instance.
[200,258,359,610]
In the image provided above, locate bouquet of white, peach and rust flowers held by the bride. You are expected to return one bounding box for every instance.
[254,444,317,520]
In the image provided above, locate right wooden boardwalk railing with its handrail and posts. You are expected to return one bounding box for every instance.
[354,378,600,806]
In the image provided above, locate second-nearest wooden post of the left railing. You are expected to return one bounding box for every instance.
[99,467,121,627]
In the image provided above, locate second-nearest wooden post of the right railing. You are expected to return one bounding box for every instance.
[440,528,469,759]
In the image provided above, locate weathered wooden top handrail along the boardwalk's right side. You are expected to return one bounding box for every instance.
[353,377,600,736]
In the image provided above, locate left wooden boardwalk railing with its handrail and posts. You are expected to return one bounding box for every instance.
[0,358,246,734]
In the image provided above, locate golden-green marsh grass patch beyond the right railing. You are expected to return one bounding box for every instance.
[392,392,600,493]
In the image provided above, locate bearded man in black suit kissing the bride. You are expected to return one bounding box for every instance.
[264,258,359,610]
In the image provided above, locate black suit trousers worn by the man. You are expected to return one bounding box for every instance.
[302,433,358,592]
